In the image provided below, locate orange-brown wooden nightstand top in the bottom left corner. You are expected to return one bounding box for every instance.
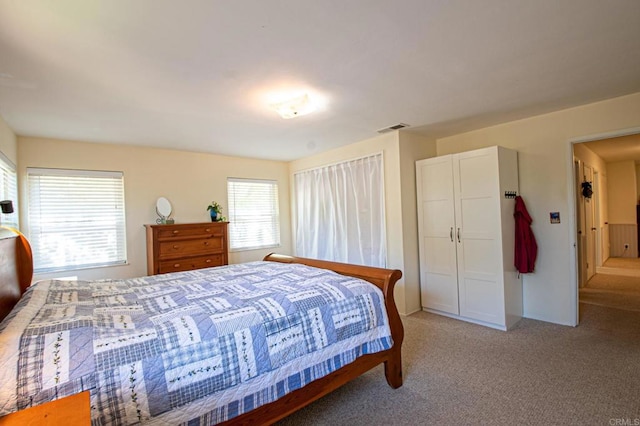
[0,391,91,426]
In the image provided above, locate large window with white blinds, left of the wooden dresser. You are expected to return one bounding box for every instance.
[27,168,127,272]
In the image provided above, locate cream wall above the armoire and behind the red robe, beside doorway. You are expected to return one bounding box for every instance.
[437,93,640,325]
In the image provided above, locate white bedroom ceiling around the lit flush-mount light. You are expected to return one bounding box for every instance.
[0,0,640,160]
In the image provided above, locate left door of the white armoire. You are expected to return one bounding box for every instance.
[416,155,459,315]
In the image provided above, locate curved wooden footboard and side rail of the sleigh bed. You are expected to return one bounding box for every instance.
[221,253,404,425]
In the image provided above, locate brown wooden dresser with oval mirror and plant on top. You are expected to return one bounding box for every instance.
[145,222,229,275]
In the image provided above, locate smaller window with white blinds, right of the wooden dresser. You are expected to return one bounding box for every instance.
[227,178,280,250]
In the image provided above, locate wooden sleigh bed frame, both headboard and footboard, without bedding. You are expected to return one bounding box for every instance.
[0,227,404,425]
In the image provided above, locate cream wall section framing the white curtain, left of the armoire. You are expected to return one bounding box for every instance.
[289,132,435,314]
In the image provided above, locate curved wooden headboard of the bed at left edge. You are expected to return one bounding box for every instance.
[0,226,33,321]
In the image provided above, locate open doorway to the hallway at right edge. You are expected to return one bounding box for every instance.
[573,133,640,319]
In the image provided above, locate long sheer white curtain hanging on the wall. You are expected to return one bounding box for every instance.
[294,154,387,267]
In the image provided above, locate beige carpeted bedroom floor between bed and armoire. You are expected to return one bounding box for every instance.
[279,304,640,426]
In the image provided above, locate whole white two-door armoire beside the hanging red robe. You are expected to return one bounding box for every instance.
[416,146,522,330]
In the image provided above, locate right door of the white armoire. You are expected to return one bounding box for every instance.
[453,150,504,323]
